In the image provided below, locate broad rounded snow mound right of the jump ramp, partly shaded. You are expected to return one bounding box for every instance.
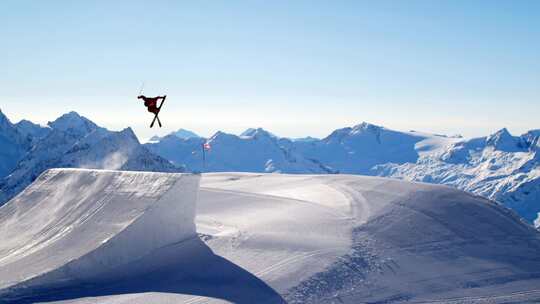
[197,174,540,303]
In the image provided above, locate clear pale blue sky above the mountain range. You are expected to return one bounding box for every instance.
[0,0,540,139]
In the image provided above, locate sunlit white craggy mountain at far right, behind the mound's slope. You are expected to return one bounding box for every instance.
[373,129,540,222]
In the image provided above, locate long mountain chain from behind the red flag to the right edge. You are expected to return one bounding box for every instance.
[147,123,540,225]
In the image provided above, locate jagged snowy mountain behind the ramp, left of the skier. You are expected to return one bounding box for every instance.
[0,112,183,204]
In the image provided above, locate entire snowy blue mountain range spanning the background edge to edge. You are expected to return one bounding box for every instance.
[0,112,540,226]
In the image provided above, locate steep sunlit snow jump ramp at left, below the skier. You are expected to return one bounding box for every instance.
[0,169,200,302]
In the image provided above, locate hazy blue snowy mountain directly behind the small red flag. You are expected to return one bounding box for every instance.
[145,128,334,173]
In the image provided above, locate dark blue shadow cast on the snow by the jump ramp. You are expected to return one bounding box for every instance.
[0,238,285,304]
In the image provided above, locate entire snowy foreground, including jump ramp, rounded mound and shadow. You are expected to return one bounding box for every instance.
[0,169,540,303]
